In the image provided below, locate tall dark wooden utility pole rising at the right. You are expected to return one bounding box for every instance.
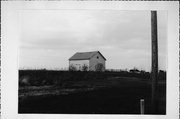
[151,11,158,114]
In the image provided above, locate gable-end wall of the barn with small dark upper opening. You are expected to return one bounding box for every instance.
[89,53,105,71]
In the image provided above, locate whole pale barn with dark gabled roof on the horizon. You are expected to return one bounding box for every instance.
[69,51,106,71]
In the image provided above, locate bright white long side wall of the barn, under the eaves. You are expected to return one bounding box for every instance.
[69,60,89,70]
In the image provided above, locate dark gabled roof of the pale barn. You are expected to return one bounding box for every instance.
[69,51,106,60]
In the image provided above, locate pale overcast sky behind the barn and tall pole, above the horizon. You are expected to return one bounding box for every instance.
[19,10,167,71]
